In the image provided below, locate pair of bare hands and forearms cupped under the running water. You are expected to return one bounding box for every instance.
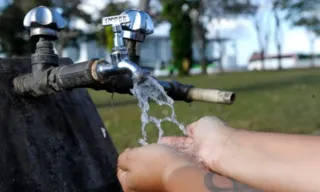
[118,117,320,192]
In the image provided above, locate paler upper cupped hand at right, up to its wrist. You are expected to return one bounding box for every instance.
[161,117,235,171]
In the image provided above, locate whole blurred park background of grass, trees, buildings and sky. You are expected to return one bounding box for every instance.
[0,0,320,150]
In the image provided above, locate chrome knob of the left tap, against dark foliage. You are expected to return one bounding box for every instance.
[23,6,67,40]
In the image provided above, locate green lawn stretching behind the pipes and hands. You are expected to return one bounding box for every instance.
[90,69,320,151]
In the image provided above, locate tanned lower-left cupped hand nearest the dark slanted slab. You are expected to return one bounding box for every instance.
[118,144,195,192]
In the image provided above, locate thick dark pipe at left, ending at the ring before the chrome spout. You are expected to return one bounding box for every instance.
[13,59,98,97]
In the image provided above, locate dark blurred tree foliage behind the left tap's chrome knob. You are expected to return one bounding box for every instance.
[0,0,93,56]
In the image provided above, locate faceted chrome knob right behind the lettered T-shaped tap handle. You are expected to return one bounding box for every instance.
[121,9,154,42]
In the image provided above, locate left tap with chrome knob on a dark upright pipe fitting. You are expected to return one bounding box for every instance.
[13,6,70,96]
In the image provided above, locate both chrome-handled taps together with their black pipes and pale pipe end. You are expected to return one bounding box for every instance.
[13,6,235,104]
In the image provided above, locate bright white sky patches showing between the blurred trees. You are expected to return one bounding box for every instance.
[0,0,320,65]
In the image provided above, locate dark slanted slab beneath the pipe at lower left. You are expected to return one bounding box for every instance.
[0,58,121,192]
